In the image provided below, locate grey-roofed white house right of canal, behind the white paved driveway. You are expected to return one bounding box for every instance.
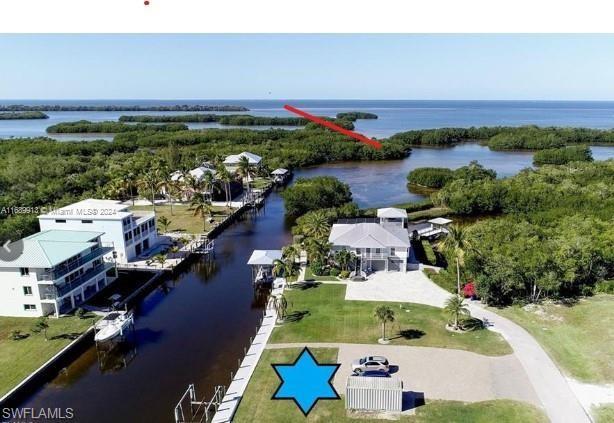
[328,213,411,272]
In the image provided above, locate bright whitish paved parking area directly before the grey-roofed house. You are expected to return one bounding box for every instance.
[345,270,450,307]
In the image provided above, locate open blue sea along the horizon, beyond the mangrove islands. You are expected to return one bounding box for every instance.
[0,100,614,139]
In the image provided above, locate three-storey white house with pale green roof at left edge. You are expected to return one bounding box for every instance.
[0,230,115,317]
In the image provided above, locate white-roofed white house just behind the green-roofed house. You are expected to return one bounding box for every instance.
[38,199,158,263]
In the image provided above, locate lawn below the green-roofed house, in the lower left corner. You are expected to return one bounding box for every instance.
[0,316,93,396]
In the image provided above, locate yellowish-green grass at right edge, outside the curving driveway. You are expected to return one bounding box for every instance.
[496,294,614,383]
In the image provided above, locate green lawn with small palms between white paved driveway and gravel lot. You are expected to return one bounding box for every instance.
[270,284,512,355]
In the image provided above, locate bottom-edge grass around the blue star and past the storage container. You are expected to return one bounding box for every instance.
[233,348,547,423]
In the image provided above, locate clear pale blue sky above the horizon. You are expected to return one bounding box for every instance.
[0,34,614,100]
